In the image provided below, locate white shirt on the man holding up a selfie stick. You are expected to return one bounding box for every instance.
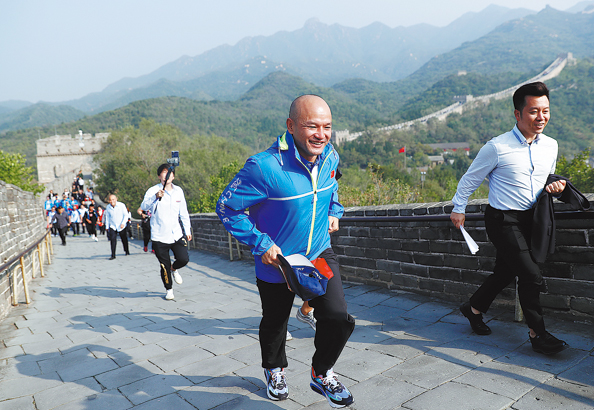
[140,184,192,243]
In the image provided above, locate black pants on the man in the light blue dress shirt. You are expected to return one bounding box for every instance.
[470,206,545,334]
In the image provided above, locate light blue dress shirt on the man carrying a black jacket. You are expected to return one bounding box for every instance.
[452,126,558,214]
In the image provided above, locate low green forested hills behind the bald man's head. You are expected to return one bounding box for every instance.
[0,66,531,165]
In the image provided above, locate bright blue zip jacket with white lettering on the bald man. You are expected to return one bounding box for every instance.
[217,131,344,283]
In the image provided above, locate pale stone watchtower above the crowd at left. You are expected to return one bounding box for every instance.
[37,131,109,193]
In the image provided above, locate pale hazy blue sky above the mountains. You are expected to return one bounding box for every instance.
[0,0,579,103]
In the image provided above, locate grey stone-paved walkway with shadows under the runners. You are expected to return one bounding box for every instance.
[0,236,594,410]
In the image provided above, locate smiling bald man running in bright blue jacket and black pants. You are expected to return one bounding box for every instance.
[217,95,355,408]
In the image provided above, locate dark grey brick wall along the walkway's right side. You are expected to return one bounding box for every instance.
[147,194,594,320]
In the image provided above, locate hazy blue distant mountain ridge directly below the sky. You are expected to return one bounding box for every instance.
[0,5,534,115]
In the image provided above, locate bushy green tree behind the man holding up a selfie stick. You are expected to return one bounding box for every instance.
[96,120,250,212]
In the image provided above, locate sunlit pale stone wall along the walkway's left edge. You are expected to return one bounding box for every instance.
[0,181,46,318]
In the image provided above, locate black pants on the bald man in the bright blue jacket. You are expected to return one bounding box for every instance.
[257,248,355,374]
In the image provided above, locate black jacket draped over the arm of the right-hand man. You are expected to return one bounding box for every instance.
[530,174,590,262]
